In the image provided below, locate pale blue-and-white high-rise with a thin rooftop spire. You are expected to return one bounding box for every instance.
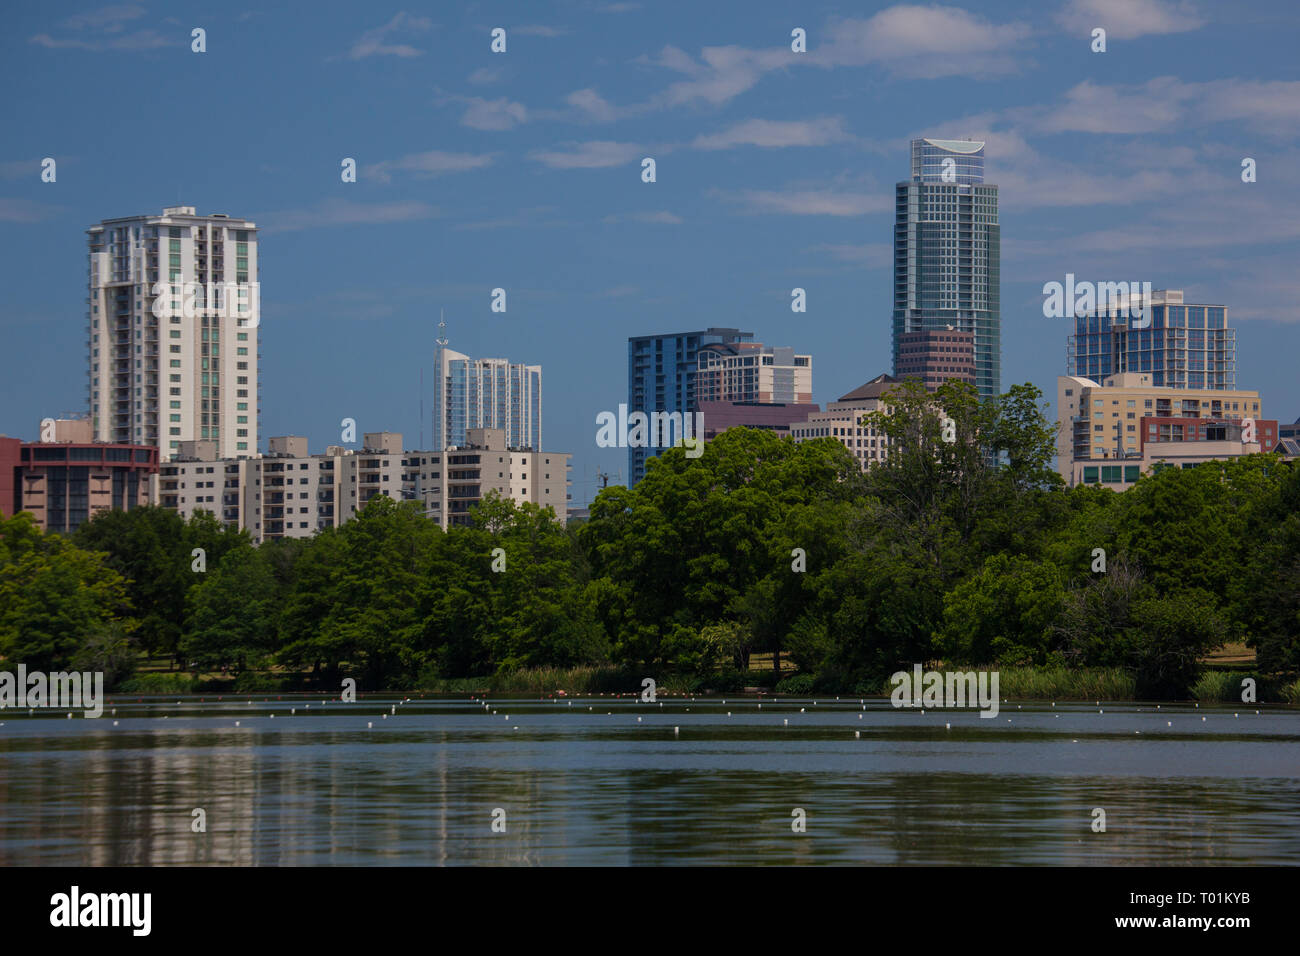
[433,323,542,451]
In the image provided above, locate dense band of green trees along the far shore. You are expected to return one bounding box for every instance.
[0,382,1300,697]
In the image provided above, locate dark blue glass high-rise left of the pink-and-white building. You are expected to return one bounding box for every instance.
[627,328,759,488]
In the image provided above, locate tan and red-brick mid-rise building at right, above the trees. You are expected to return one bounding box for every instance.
[1057,372,1278,490]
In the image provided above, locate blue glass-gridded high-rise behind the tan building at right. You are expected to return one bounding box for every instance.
[1066,289,1236,392]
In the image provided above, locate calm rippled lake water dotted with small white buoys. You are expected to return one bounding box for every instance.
[0,697,1300,865]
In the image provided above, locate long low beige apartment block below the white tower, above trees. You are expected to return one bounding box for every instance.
[150,428,569,544]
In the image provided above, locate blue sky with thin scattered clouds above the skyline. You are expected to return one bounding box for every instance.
[0,0,1300,506]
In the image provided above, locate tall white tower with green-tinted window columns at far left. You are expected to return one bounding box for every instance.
[86,206,260,460]
